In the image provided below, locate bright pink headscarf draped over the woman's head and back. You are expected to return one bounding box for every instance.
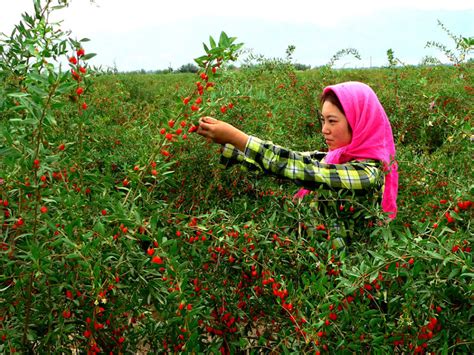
[295,81,398,218]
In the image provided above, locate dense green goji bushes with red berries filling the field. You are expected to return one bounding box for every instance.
[0,0,474,353]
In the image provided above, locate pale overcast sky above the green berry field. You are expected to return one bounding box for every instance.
[0,0,474,71]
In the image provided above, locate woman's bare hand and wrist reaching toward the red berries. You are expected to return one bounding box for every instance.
[197,117,248,151]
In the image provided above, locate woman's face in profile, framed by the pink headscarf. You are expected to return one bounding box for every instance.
[321,100,352,150]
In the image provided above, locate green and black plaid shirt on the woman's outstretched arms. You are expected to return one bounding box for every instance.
[220,136,384,192]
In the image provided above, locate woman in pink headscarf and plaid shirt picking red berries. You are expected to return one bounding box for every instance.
[197,82,398,219]
